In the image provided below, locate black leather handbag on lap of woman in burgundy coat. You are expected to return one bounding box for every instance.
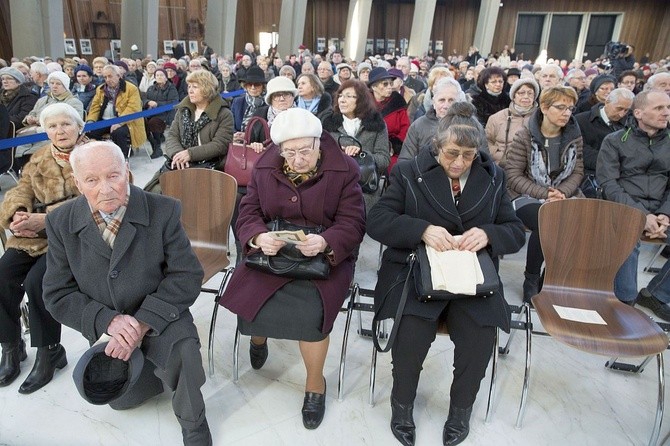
[244,219,330,280]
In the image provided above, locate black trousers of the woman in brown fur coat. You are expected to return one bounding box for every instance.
[0,248,61,347]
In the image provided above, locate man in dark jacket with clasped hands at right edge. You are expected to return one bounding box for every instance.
[596,91,670,310]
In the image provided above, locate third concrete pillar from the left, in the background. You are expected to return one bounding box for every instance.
[205,0,237,60]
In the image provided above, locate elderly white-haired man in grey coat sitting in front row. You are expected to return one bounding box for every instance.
[44,141,212,445]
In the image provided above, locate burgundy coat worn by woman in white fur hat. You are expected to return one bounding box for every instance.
[220,132,365,333]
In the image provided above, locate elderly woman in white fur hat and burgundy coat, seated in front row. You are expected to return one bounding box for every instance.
[220,107,365,429]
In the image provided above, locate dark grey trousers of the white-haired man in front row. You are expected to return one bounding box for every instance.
[110,338,205,429]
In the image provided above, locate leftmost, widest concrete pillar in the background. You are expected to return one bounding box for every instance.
[9,0,64,60]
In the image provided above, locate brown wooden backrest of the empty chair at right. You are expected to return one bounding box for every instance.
[539,198,645,298]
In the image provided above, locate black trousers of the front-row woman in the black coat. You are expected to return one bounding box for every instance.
[391,305,495,409]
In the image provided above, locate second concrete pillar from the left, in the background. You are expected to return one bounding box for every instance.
[121,0,158,59]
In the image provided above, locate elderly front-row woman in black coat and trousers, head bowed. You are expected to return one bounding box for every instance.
[367,102,525,445]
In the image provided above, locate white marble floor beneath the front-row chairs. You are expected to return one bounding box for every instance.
[0,148,670,446]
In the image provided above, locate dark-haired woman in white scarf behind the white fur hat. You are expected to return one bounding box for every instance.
[323,80,391,211]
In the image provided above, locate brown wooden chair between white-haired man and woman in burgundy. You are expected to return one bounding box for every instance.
[160,169,237,375]
